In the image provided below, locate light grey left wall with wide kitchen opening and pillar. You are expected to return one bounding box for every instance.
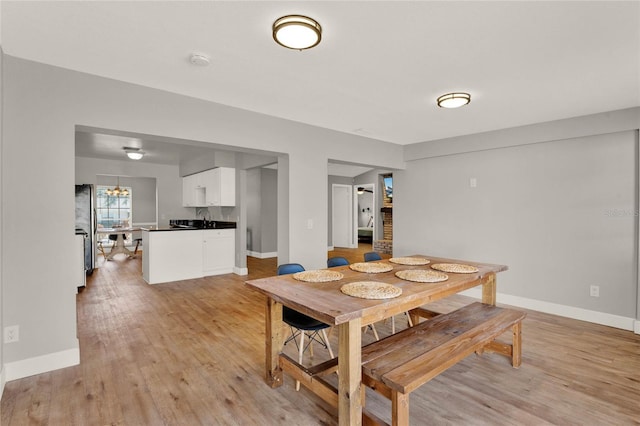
[1,55,404,379]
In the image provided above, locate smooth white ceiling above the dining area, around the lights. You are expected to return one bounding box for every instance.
[0,0,640,149]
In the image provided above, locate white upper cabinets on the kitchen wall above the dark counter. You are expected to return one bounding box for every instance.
[182,167,236,207]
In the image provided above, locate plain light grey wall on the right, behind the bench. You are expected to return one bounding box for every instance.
[393,108,640,328]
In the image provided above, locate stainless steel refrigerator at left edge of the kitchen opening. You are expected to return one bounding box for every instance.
[76,184,97,274]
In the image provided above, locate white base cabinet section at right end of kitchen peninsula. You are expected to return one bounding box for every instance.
[202,229,236,276]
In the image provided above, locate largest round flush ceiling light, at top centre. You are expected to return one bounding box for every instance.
[273,15,322,50]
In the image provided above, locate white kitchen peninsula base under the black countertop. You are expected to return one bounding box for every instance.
[142,224,236,284]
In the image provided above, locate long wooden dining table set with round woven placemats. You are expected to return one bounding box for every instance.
[246,255,507,425]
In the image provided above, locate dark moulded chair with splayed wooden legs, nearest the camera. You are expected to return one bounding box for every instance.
[278,263,333,390]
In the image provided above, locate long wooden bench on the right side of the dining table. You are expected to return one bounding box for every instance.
[362,303,525,426]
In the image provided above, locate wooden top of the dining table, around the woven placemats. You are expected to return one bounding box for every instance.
[246,255,507,325]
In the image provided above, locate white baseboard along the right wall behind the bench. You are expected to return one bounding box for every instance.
[460,288,640,334]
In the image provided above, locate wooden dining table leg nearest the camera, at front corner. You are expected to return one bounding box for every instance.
[338,318,362,426]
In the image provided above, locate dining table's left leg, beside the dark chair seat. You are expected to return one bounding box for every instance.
[264,297,284,388]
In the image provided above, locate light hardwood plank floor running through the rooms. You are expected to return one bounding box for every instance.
[0,245,640,426]
